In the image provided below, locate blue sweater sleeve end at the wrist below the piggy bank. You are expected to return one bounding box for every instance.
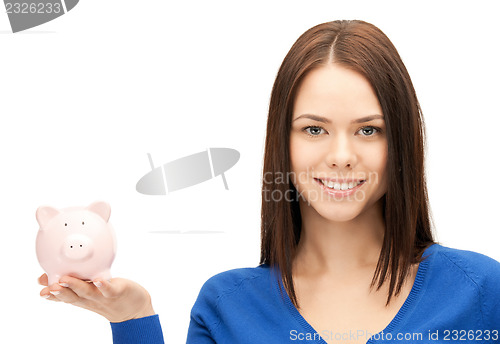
[111,314,164,344]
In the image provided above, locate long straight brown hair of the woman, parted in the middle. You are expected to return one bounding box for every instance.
[260,20,434,307]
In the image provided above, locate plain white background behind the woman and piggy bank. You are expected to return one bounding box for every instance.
[0,0,500,344]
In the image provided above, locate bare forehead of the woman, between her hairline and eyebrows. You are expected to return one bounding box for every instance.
[293,63,382,119]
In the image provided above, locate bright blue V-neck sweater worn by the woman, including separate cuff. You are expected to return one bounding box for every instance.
[111,244,500,344]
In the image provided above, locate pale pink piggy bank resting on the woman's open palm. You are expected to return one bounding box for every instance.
[36,202,116,285]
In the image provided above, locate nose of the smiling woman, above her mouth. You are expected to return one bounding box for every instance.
[325,133,358,171]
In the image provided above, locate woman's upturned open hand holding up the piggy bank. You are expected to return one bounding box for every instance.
[38,274,155,322]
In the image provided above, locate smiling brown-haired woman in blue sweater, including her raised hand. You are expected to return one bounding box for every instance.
[40,21,500,343]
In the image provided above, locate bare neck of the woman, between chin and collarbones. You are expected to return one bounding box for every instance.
[294,200,385,275]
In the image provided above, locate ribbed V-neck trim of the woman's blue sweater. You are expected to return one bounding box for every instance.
[278,243,439,344]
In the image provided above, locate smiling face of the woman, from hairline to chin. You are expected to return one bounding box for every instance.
[290,63,387,222]
